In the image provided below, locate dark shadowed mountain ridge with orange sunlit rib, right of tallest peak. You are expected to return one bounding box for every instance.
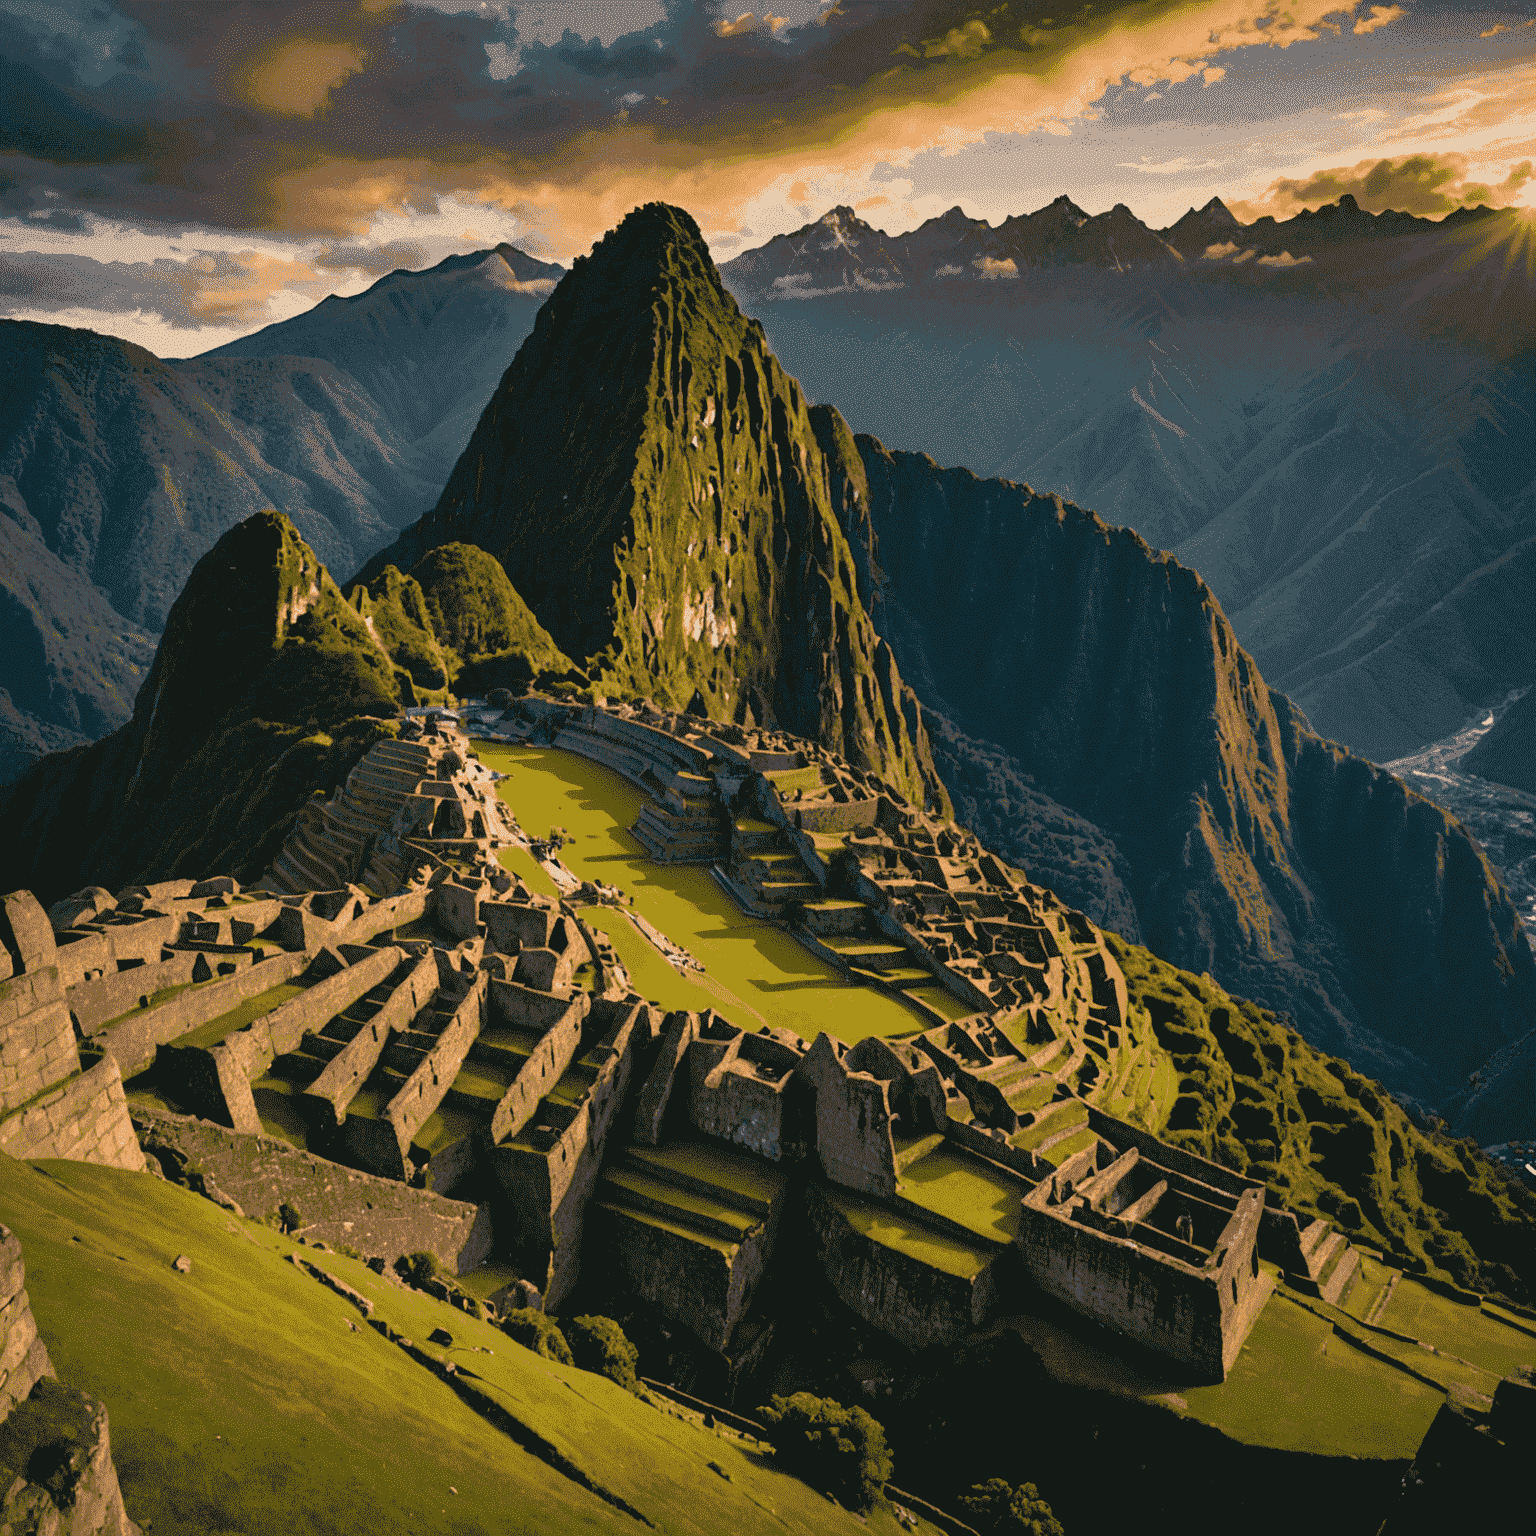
[817,427,1536,1136]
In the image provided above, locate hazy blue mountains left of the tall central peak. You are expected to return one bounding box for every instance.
[0,246,561,782]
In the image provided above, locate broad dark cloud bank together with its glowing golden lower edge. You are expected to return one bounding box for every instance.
[0,0,1513,339]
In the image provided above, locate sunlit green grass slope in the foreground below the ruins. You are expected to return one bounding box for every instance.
[0,1158,921,1536]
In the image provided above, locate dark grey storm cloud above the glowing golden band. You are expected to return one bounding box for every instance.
[0,0,1052,232]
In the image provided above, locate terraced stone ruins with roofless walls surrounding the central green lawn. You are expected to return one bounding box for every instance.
[0,697,1358,1406]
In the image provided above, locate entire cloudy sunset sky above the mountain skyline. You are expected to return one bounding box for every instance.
[0,0,1536,356]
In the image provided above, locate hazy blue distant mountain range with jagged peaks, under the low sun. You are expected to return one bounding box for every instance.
[722,198,1536,760]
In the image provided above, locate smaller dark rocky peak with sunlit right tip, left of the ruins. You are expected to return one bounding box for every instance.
[0,511,419,903]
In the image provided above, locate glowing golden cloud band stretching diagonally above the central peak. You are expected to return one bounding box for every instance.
[236,0,1425,262]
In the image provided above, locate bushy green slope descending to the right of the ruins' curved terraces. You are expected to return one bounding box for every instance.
[1104,934,1536,1301]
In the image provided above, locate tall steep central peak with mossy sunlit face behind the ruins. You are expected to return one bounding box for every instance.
[361,203,948,806]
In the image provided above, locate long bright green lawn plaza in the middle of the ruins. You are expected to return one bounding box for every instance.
[475,740,925,1043]
